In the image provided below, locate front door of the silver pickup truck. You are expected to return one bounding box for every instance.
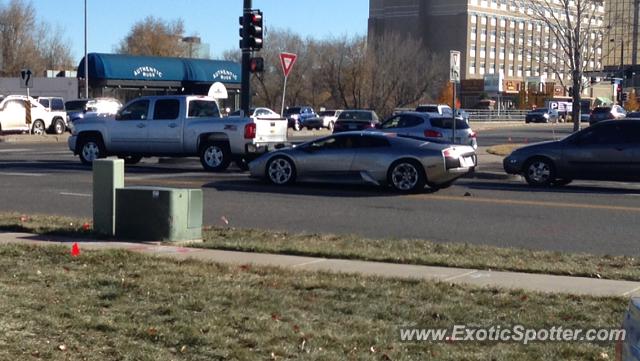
[107,99,151,154]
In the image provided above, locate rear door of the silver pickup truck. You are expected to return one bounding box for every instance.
[147,99,185,154]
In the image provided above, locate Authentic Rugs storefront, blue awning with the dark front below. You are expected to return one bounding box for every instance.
[78,53,241,109]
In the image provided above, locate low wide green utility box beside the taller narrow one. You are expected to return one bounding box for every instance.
[115,187,203,242]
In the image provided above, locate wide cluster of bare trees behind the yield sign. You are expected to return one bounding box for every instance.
[224,29,446,115]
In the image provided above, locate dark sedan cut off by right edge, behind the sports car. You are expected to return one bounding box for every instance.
[503,119,640,186]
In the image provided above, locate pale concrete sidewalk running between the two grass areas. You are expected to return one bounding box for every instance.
[0,233,640,297]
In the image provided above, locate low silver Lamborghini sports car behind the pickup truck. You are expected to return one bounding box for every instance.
[249,132,476,193]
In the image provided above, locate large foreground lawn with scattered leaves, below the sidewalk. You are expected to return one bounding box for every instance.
[0,245,627,361]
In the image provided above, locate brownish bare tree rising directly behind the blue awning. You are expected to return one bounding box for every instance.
[116,16,186,57]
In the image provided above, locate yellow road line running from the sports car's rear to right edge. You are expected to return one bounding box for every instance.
[407,194,640,212]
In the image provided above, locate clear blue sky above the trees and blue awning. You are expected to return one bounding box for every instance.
[30,0,369,61]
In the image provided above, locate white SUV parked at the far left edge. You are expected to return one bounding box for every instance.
[0,95,66,134]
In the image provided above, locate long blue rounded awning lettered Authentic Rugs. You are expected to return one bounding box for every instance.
[78,53,241,84]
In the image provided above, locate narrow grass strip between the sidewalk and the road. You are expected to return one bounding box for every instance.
[0,213,640,281]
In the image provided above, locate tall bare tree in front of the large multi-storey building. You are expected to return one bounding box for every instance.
[521,0,607,131]
